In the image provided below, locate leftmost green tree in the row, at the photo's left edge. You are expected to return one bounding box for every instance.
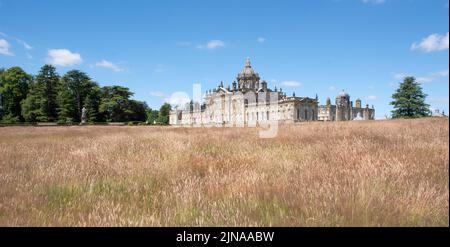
[0,67,33,121]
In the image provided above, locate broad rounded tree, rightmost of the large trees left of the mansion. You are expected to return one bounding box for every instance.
[100,86,133,122]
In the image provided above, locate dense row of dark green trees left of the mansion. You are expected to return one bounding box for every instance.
[0,64,170,124]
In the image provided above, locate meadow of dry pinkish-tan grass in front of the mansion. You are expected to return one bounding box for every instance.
[0,118,449,226]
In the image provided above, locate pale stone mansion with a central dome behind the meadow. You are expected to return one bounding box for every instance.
[169,58,374,126]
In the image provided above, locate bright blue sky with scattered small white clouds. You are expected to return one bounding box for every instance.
[0,0,449,118]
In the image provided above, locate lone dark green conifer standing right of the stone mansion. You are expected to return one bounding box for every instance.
[390,77,430,118]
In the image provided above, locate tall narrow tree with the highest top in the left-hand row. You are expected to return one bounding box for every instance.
[36,64,60,122]
